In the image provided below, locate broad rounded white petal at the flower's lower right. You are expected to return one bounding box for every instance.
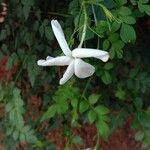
[74,58,95,78]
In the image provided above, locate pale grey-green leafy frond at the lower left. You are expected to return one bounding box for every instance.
[0,85,37,143]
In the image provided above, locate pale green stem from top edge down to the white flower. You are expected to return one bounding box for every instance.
[78,1,88,48]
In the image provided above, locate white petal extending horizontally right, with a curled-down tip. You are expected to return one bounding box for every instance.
[72,48,109,62]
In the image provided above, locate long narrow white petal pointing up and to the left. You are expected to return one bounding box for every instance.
[51,20,71,56]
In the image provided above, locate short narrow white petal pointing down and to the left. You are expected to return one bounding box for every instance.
[59,60,74,84]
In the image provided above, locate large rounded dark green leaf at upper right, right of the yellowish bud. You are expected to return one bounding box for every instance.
[120,24,136,43]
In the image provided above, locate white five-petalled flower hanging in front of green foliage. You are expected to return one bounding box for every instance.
[37,20,109,84]
